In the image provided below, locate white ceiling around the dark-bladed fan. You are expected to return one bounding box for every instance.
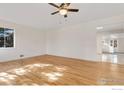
[0,3,124,28]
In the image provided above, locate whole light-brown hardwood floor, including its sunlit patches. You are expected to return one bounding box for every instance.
[0,55,124,85]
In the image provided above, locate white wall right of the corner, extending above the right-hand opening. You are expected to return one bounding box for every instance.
[47,16,124,61]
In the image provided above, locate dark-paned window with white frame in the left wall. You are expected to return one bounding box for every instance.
[0,27,14,48]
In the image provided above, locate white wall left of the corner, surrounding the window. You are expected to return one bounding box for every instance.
[0,20,46,62]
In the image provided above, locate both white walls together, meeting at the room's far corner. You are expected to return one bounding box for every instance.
[0,16,124,62]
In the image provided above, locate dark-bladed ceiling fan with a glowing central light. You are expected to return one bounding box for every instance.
[49,3,79,18]
